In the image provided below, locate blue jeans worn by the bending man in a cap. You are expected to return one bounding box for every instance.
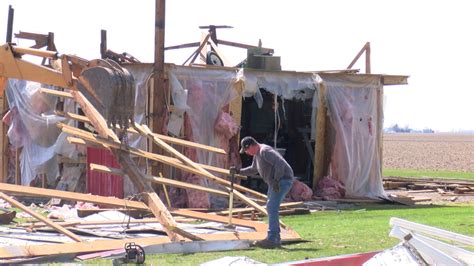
[267,179,293,244]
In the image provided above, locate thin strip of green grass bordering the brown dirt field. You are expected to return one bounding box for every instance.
[382,169,474,179]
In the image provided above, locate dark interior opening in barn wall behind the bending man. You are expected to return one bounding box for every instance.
[240,89,314,193]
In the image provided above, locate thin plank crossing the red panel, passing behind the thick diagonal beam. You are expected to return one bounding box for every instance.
[90,163,229,197]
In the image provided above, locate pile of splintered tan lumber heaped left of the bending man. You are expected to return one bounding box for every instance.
[0,89,300,259]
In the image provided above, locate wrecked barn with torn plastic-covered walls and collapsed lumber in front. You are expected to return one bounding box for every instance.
[0,3,407,258]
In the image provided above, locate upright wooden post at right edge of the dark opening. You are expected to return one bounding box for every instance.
[313,83,327,191]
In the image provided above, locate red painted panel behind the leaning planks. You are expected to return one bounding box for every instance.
[86,147,123,198]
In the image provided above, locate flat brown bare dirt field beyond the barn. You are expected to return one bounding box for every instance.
[383,133,474,172]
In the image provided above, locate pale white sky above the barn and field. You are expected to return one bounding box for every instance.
[0,0,474,131]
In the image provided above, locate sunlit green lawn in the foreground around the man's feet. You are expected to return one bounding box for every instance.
[87,204,474,265]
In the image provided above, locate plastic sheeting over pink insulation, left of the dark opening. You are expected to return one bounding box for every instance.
[168,66,238,208]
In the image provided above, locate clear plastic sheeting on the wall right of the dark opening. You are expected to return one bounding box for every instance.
[321,74,386,198]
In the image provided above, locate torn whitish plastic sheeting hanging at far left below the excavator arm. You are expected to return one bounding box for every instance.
[6,79,65,185]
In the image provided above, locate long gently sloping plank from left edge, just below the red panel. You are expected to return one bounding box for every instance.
[0,184,148,210]
